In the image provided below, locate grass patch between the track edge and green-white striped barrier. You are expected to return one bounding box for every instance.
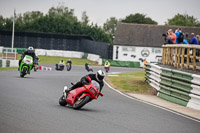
[106,71,153,93]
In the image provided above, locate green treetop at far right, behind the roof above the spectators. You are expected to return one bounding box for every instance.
[165,13,200,27]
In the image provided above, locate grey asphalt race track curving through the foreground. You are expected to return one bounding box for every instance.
[0,66,200,133]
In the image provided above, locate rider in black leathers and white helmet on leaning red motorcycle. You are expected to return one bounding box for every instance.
[64,70,105,96]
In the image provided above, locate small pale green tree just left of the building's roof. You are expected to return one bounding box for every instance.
[103,17,118,35]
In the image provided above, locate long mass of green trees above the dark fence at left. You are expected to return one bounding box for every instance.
[0,5,112,43]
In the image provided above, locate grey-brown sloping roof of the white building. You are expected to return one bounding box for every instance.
[114,22,200,47]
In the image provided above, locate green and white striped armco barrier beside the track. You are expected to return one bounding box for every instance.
[145,63,200,110]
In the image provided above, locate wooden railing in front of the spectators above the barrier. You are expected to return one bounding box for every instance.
[162,44,200,70]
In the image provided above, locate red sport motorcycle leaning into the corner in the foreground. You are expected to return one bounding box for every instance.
[59,76,103,109]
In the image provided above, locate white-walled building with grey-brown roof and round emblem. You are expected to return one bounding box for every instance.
[113,23,164,67]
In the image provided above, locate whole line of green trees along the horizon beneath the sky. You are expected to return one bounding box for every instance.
[0,5,200,44]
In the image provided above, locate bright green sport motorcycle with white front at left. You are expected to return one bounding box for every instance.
[19,55,33,77]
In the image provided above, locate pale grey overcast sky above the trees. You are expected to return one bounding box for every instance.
[0,0,200,26]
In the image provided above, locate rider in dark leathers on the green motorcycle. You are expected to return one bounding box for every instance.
[18,46,37,70]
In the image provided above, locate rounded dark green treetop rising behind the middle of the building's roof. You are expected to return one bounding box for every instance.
[121,13,158,25]
